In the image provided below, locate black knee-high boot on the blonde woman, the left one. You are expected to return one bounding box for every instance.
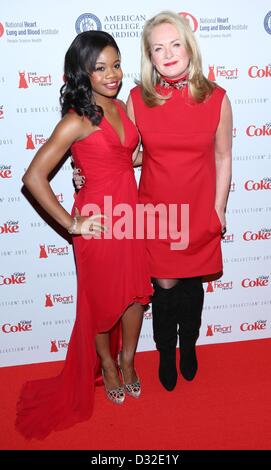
[152,281,179,391]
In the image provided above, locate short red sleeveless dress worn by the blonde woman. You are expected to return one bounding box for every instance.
[131,86,225,278]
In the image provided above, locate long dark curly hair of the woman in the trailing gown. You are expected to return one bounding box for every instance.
[60,31,120,125]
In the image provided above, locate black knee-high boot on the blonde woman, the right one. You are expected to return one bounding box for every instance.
[178,277,204,380]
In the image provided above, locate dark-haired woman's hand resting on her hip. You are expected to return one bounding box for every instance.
[68,208,107,237]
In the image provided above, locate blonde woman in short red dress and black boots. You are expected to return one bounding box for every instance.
[127,12,232,390]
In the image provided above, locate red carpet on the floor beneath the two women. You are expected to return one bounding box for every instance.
[0,339,271,450]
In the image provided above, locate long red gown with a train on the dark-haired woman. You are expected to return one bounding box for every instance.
[16,101,153,439]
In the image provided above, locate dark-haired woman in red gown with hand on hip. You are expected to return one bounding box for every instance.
[16,31,153,438]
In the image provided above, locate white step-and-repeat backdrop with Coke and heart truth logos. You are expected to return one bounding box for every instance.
[0,0,271,366]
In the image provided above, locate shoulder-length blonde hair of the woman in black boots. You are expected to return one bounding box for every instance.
[138,11,216,107]
